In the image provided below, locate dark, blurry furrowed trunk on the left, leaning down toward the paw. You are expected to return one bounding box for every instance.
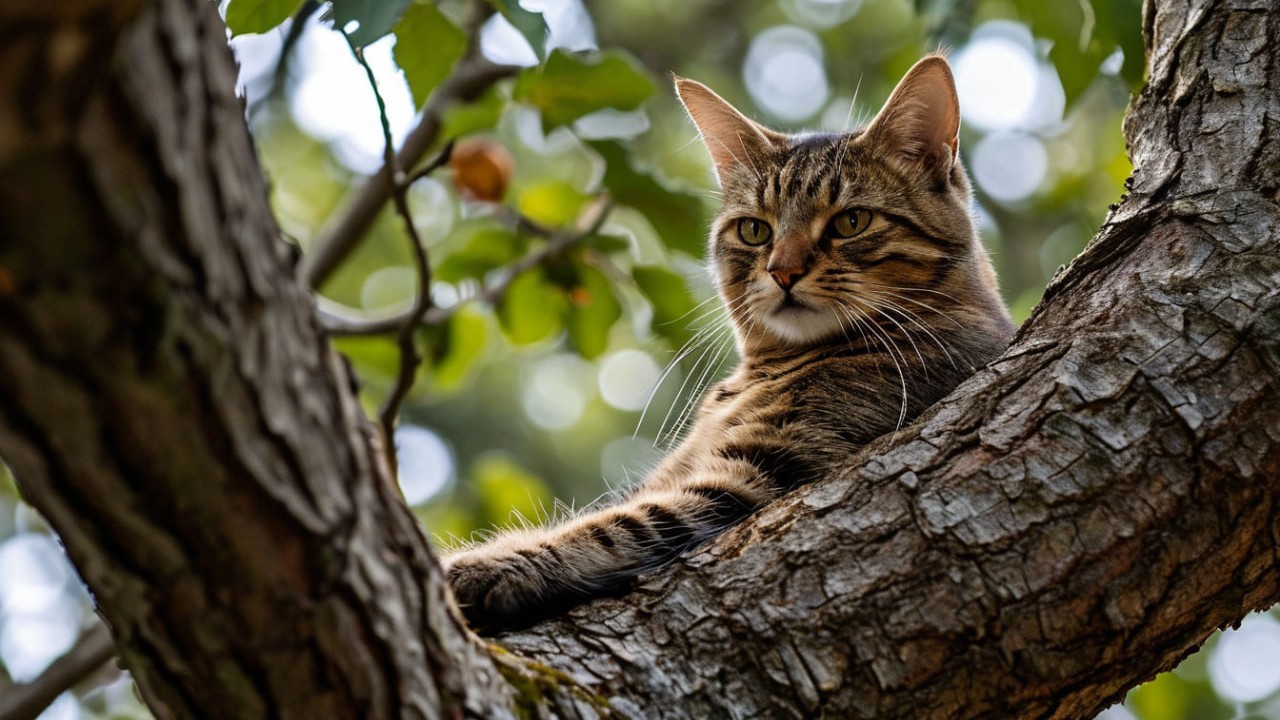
[0,0,509,719]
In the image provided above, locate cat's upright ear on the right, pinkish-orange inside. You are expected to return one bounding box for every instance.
[863,55,960,178]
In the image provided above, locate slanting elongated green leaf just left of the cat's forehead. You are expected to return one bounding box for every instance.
[590,141,708,258]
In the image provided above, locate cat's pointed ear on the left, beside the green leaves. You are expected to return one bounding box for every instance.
[676,76,786,187]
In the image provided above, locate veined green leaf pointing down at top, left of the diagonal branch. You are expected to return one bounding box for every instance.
[394,3,467,108]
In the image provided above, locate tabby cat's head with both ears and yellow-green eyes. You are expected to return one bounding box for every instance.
[676,55,1002,354]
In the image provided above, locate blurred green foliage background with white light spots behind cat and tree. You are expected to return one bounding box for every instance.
[0,0,1280,720]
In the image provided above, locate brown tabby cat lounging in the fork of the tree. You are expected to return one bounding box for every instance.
[444,55,1014,630]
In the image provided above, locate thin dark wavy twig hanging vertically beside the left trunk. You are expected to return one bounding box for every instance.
[343,39,435,477]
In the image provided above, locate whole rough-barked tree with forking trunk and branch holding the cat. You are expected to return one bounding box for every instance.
[0,0,1280,717]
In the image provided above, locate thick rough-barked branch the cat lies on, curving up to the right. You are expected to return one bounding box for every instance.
[500,0,1280,719]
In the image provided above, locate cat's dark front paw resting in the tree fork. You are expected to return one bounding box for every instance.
[444,550,553,630]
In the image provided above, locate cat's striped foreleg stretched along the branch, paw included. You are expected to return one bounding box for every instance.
[444,459,777,629]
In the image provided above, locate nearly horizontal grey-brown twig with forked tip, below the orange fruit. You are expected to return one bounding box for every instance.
[319,196,613,336]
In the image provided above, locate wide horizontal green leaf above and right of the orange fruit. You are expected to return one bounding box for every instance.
[513,50,654,132]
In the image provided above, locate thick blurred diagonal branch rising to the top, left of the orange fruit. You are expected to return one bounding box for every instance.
[298,3,520,287]
